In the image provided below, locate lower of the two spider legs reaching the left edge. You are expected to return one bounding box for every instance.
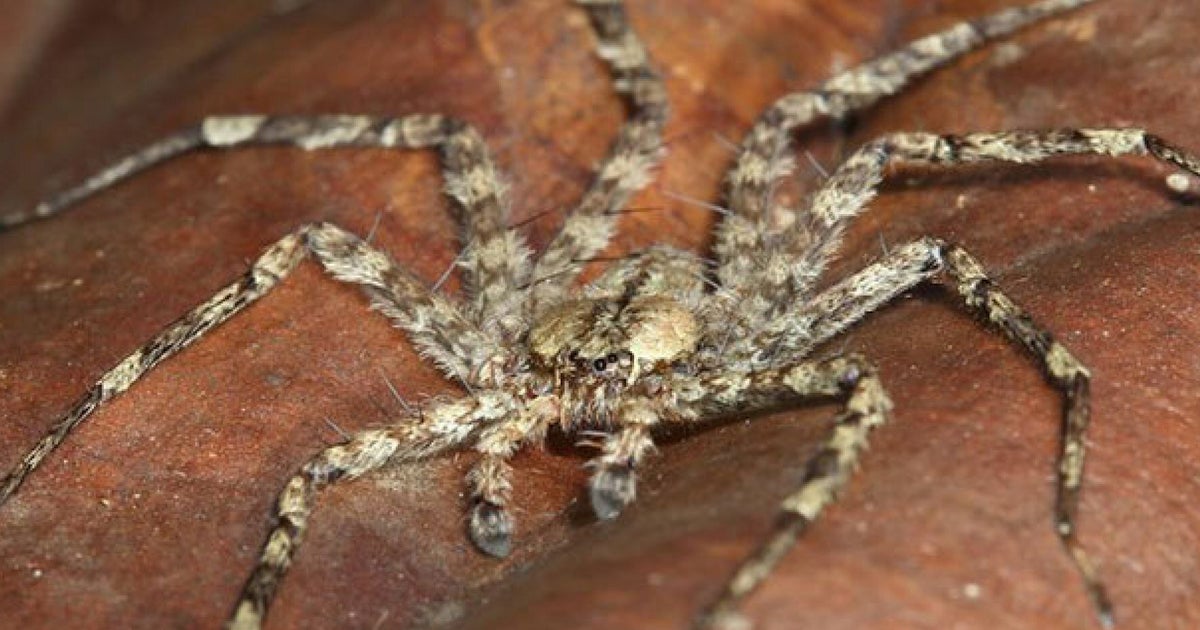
[0,223,506,505]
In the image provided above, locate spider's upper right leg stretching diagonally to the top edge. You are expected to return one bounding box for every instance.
[714,0,1093,298]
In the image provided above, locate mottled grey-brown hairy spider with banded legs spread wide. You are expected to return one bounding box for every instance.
[0,0,1200,628]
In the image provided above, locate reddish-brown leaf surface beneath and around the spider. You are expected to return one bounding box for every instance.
[0,0,1200,629]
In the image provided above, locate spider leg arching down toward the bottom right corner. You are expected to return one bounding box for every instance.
[763,238,1112,626]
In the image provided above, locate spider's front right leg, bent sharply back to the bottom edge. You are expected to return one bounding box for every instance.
[695,355,892,629]
